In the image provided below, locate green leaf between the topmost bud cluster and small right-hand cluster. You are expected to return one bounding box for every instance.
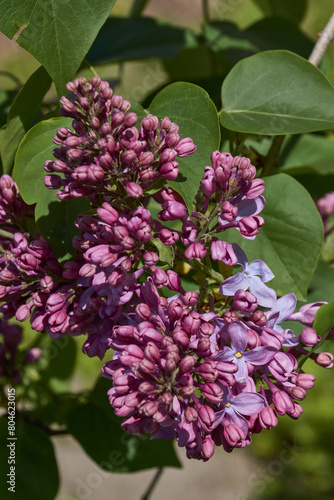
[149,83,220,212]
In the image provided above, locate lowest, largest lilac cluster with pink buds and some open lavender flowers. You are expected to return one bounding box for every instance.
[103,274,333,461]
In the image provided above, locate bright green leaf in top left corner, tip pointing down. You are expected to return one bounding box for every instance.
[0,0,116,96]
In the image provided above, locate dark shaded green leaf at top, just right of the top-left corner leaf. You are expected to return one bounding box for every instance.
[86,17,193,64]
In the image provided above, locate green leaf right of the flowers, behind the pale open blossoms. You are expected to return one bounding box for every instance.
[221,174,323,300]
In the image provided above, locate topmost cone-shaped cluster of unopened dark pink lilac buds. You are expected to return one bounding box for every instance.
[44,77,196,204]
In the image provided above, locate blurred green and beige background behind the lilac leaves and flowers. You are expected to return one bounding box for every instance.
[0,0,334,500]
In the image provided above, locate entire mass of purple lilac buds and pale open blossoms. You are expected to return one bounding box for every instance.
[0,77,333,461]
